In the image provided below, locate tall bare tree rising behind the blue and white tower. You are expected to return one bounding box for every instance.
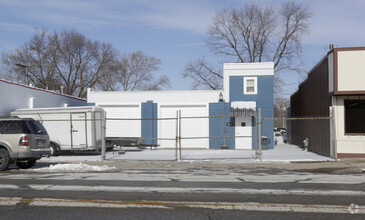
[183,1,311,87]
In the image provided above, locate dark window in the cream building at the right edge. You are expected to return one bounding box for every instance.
[345,99,365,134]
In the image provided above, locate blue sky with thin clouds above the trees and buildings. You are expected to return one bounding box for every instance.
[0,0,365,96]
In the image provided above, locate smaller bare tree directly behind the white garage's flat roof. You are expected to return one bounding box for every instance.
[100,51,170,91]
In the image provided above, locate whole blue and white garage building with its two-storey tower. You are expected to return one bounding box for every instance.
[87,63,274,149]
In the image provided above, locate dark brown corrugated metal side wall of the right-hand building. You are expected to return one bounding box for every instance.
[290,58,331,156]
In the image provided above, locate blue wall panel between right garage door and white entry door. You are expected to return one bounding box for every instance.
[209,101,235,149]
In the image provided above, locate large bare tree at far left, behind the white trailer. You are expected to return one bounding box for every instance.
[2,30,117,97]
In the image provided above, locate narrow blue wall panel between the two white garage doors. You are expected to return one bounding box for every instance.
[141,101,157,144]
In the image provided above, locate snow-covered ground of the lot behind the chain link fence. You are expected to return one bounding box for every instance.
[42,144,333,163]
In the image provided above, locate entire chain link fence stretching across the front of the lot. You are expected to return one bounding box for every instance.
[11,109,336,161]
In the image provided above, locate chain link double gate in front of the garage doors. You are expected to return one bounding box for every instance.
[106,110,257,161]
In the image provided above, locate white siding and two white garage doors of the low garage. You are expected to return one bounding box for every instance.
[88,90,216,148]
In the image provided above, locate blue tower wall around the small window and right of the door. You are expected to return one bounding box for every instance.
[229,75,274,149]
